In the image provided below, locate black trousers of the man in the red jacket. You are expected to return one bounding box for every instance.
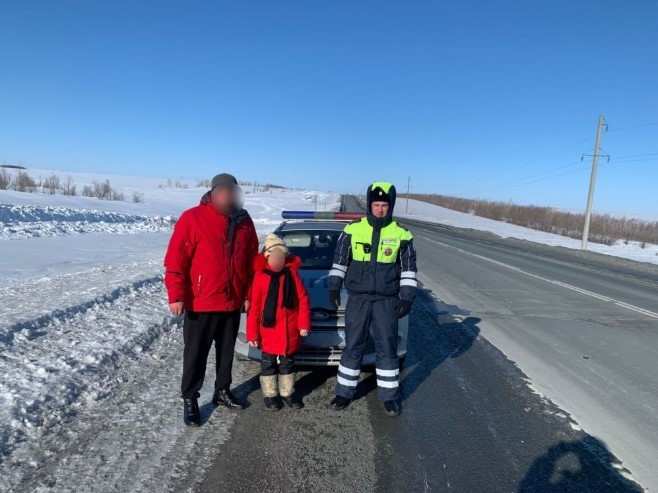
[181,310,240,399]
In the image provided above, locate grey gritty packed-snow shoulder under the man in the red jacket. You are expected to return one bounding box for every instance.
[2,325,258,493]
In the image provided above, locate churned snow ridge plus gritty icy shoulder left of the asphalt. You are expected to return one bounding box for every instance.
[0,272,258,492]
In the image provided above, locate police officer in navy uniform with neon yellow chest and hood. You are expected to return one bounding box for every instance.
[329,182,418,416]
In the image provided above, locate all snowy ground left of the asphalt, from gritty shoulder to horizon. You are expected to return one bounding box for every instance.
[0,168,339,492]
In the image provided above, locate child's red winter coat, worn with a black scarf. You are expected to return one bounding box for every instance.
[247,255,311,356]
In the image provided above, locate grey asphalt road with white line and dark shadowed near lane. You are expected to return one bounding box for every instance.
[197,198,658,493]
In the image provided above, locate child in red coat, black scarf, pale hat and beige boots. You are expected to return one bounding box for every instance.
[247,234,311,411]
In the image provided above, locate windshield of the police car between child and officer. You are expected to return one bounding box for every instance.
[280,231,341,270]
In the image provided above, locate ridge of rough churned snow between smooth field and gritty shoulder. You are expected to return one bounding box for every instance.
[0,278,172,472]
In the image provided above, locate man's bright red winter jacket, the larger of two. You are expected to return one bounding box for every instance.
[164,194,258,312]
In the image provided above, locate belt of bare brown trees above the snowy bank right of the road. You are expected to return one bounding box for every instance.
[400,194,658,247]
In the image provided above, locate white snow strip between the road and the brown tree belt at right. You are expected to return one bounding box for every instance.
[396,199,658,264]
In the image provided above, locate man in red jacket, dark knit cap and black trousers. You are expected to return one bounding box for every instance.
[164,173,258,426]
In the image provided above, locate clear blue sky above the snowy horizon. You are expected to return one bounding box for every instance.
[0,0,658,218]
